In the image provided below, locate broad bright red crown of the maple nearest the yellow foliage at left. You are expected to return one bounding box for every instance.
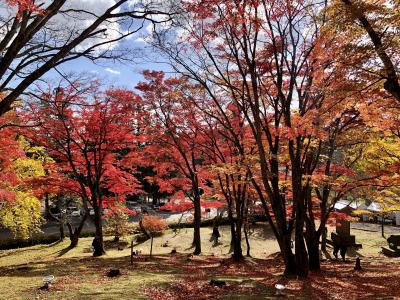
[26,82,142,209]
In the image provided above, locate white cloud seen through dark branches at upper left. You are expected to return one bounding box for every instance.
[0,0,171,55]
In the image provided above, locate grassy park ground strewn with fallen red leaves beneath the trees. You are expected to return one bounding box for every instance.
[0,226,400,300]
